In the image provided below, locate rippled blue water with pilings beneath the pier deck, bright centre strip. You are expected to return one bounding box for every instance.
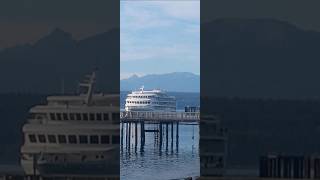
[120,122,200,179]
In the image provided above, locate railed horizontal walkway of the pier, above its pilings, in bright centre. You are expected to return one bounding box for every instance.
[120,111,200,122]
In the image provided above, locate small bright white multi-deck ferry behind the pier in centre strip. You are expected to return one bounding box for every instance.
[125,87,177,112]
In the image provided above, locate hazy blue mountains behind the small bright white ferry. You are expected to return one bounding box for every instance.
[120,72,200,92]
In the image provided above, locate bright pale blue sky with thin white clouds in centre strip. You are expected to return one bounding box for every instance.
[120,0,200,79]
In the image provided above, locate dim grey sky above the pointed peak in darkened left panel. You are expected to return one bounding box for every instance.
[0,0,120,48]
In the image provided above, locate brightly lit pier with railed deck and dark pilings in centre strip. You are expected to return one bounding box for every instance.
[120,111,200,152]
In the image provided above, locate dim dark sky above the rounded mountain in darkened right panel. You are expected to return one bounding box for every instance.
[201,0,320,31]
